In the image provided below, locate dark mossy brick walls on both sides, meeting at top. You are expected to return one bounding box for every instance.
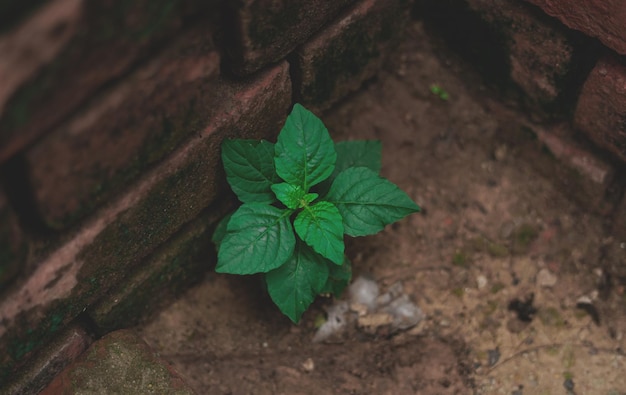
[0,0,626,393]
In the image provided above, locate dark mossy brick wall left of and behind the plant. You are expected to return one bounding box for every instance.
[0,0,411,393]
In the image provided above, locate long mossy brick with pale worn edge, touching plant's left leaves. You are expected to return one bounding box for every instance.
[0,62,291,386]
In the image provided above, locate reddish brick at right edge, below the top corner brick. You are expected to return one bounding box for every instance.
[574,56,626,161]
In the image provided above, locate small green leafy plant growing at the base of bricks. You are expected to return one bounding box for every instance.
[213,104,420,322]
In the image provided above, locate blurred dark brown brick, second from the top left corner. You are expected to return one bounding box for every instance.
[26,27,222,229]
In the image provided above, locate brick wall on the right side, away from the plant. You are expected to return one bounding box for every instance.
[414,0,626,218]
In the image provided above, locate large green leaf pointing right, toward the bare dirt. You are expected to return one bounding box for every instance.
[326,167,420,236]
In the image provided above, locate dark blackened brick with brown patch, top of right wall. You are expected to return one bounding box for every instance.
[425,0,597,118]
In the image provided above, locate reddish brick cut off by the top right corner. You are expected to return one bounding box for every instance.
[526,0,626,54]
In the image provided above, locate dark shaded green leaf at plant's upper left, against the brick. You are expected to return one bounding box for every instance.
[222,139,279,203]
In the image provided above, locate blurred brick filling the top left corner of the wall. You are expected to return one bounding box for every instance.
[0,0,216,162]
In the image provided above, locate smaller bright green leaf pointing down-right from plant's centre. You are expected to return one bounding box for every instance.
[293,201,344,265]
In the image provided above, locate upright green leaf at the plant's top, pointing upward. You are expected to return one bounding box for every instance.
[274,103,337,192]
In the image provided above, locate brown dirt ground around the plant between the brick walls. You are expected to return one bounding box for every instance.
[140,23,626,395]
